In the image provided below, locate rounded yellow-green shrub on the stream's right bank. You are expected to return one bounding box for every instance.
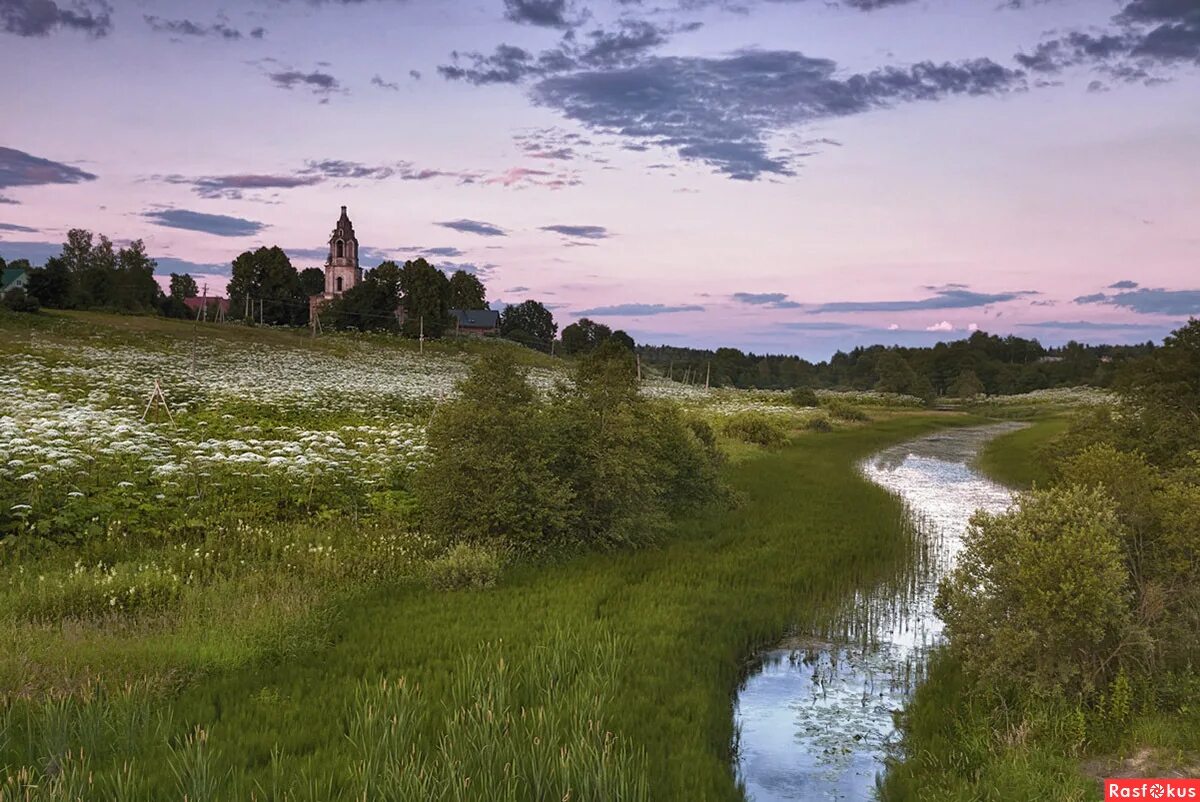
[936,487,1136,695]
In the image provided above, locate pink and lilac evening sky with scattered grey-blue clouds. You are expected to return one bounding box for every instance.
[0,0,1200,359]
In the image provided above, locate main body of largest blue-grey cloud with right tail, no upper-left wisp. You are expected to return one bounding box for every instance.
[533,50,1024,179]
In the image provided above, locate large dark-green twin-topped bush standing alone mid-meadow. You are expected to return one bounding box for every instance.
[414,341,722,553]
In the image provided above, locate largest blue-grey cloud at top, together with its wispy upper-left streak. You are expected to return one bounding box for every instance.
[438,36,1025,179]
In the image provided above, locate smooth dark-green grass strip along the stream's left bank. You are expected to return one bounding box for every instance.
[0,414,966,801]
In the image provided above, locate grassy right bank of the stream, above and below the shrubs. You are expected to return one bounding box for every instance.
[881,414,1200,802]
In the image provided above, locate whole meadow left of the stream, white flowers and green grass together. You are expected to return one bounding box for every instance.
[0,313,964,800]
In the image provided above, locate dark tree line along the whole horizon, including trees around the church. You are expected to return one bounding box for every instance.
[0,228,1154,388]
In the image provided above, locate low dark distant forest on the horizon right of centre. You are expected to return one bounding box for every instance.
[637,331,1154,399]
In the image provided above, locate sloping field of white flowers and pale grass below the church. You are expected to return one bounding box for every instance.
[0,316,945,680]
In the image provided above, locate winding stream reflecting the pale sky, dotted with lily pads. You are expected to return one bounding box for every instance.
[734,424,1020,802]
